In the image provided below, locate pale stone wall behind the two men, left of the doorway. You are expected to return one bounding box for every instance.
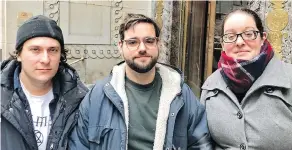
[0,0,154,84]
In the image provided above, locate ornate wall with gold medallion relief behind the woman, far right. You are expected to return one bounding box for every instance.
[249,0,292,63]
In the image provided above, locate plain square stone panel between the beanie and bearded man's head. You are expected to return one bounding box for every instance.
[60,1,111,44]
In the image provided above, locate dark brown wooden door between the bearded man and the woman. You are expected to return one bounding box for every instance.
[184,1,208,96]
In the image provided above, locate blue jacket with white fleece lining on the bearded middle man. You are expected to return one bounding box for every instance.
[69,64,212,150]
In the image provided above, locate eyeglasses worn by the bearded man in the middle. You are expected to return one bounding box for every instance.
[122,37,158,51]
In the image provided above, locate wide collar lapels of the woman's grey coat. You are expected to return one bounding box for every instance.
[202,56,291,99]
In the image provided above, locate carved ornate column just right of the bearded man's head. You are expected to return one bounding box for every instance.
[154,0,185,69]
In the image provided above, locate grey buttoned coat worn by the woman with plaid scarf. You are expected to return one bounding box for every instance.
[201,57,292,150]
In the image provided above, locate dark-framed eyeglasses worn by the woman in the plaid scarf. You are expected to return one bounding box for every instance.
[222,30,260,43]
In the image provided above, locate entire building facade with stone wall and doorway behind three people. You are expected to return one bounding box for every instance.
[0,0,292,95]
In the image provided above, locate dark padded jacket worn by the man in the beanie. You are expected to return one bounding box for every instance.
[1,60,88,150]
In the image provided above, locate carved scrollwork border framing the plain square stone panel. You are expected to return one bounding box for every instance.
[44,0,123,59]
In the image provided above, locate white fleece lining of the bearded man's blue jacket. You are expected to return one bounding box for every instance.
[110,62,183,149]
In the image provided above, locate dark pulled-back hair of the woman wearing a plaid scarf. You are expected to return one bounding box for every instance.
[221,8,264,38]
